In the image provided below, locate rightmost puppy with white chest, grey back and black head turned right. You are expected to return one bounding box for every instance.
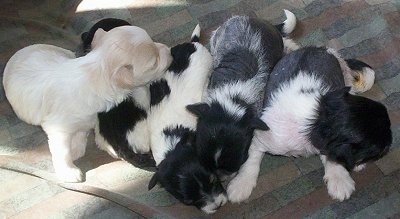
[227,47,392,202]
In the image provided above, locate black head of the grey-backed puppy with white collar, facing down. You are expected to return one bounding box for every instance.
[186,102,268,177]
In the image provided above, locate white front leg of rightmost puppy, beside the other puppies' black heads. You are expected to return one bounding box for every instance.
[227,144,264,203]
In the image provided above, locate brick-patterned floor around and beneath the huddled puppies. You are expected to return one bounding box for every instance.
[0,0,400,219]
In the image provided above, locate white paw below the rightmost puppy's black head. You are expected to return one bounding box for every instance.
[324,173,355,201]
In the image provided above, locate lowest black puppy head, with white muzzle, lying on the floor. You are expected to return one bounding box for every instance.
[149,134,227,214]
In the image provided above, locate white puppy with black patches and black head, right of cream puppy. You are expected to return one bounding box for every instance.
[148,28,227,213]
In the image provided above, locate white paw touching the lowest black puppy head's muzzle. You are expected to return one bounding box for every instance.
[227,175,257,203]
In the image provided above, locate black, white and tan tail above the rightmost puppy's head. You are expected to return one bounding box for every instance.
[345,59,375,93]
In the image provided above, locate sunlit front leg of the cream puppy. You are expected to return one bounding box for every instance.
[46,131,83,182]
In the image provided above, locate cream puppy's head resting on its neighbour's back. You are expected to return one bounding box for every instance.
[92,26,172,89]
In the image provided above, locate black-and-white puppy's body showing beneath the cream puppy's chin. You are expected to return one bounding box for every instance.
[94,86,155,168]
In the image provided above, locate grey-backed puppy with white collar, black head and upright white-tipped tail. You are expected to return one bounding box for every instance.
[187,11,296,177]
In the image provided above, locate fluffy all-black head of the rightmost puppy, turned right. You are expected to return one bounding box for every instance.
[310,87,392,170]
